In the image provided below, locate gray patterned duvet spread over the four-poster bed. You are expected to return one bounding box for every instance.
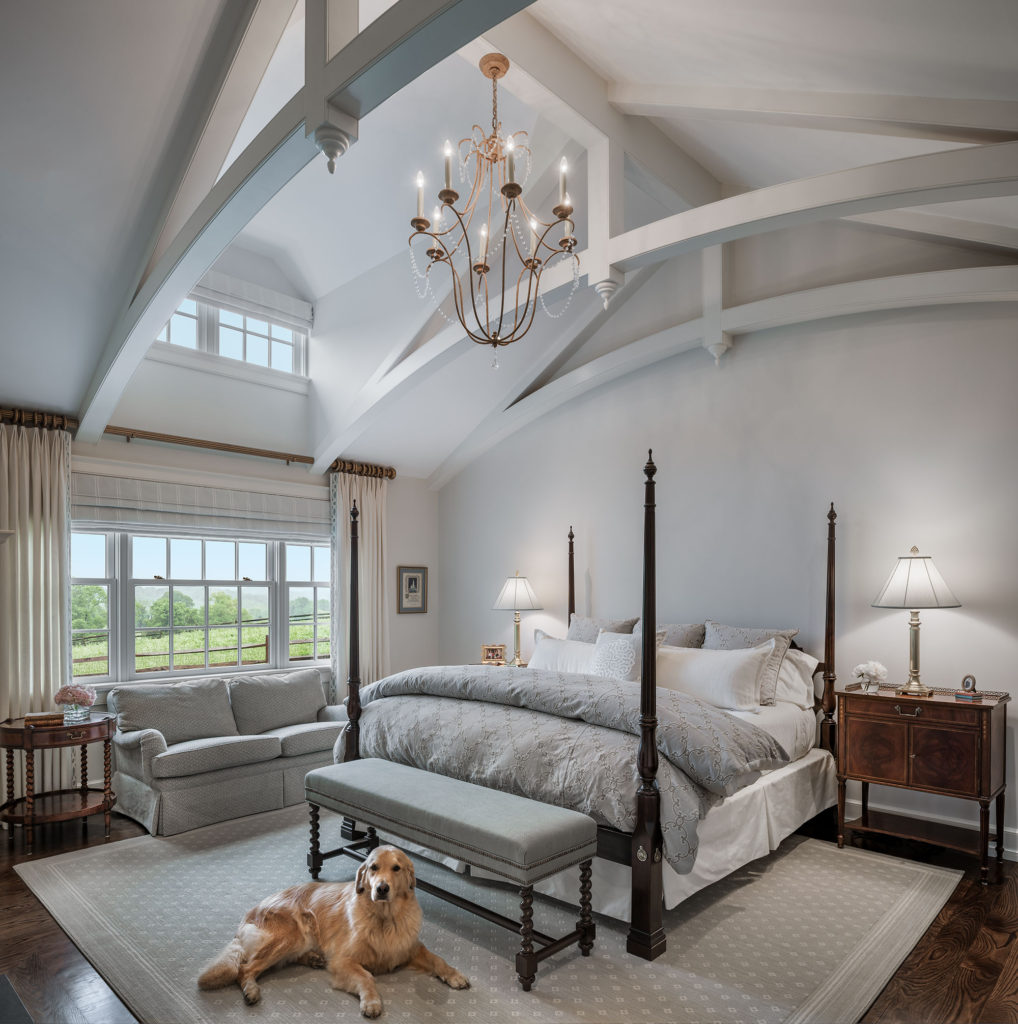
[350,666,790,873]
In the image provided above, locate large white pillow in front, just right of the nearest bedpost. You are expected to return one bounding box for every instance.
[658,638,774,711]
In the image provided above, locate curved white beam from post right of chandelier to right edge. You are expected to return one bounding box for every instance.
[609,142,1018,271]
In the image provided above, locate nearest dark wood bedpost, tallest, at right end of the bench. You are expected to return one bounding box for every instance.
[626,452,666,959]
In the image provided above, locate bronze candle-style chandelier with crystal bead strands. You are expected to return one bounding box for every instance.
[409,53,580,369]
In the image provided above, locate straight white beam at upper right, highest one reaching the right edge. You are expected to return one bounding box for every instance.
[608,83,1018,143]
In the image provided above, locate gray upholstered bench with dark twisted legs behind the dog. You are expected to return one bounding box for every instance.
[304,758,597,992]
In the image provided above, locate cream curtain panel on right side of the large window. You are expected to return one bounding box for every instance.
[329,473,389,700]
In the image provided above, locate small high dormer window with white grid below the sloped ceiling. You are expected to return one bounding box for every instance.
[156,299,307,376]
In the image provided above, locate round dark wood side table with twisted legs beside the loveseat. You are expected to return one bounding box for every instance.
[0,714,117,853]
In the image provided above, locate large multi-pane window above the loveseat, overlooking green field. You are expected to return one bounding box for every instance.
[72,530,331,679]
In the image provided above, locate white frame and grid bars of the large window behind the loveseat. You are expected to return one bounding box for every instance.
[72,523,333,683]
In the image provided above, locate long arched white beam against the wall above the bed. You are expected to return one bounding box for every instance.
[428,266,1018,489]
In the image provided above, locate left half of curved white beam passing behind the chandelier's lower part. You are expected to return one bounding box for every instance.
[311,253,583,473]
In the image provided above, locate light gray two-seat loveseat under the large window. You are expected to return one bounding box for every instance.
[107,669,347,836]
